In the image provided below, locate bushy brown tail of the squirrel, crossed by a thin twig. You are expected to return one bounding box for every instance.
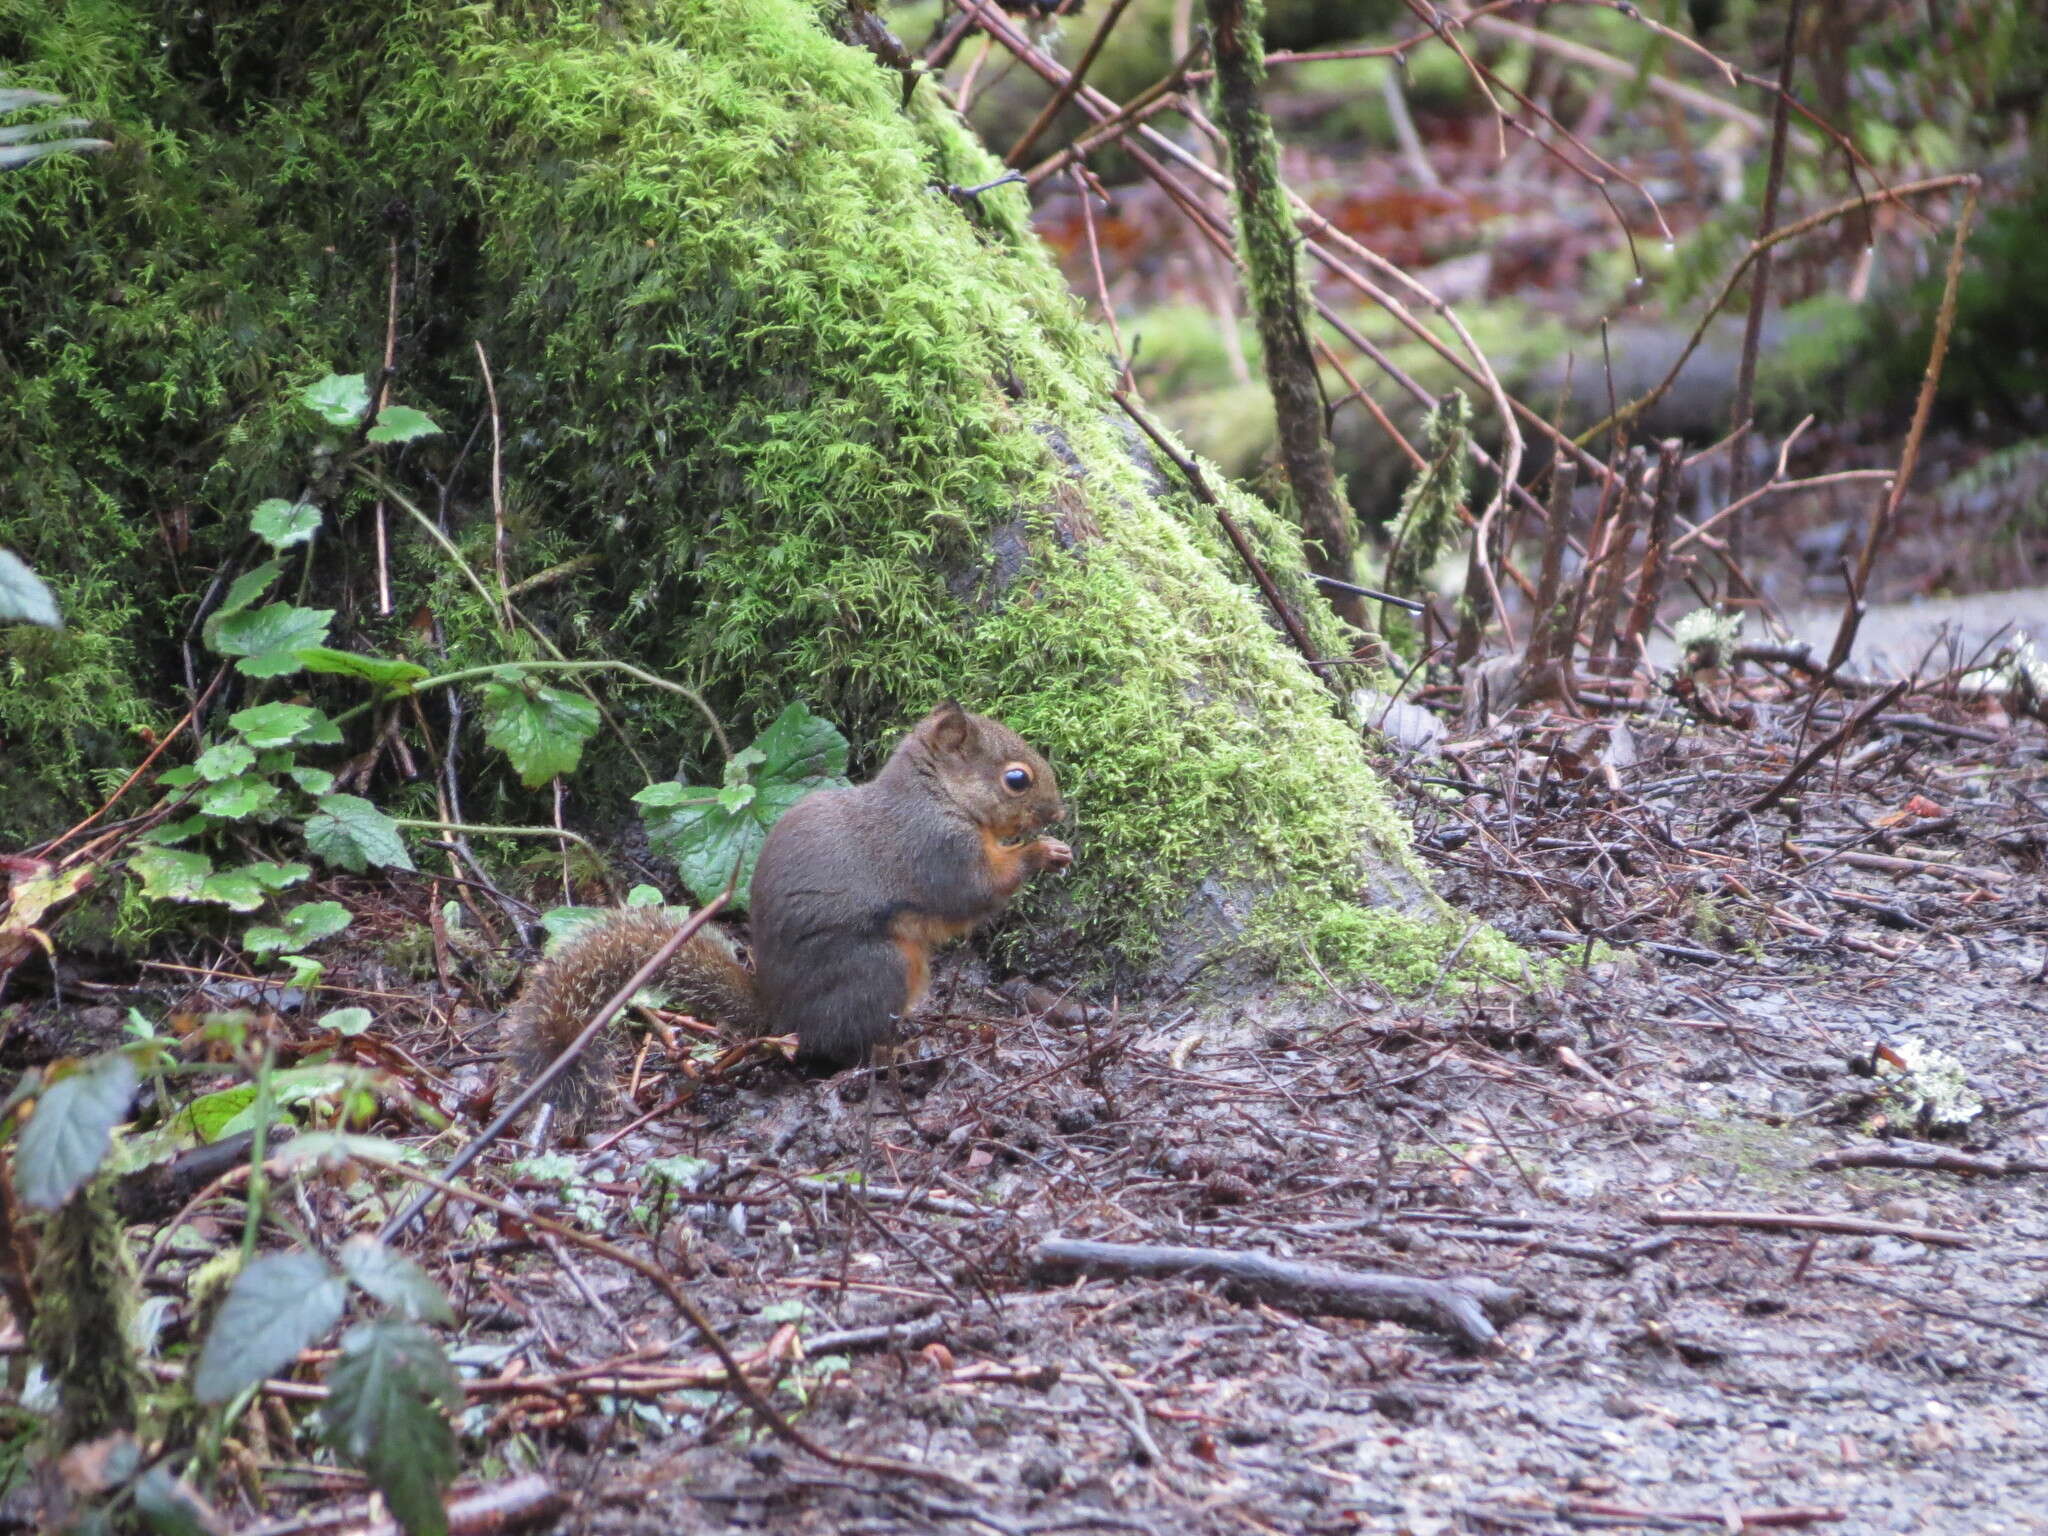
[504,907,762,1126]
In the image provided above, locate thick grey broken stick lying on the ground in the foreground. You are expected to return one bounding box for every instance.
[1032,1237,1520,1354]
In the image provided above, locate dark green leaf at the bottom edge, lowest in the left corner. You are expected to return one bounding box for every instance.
[319,1317,463,1536]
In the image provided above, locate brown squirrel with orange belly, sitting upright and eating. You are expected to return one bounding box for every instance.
[506,700,1073,1124]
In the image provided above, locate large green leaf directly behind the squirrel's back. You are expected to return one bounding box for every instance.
[633,705,846,907]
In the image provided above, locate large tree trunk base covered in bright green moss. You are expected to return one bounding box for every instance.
[0,0,1491,983]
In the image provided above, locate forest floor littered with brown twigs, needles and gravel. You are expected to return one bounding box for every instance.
[108,667,2048,1536]
